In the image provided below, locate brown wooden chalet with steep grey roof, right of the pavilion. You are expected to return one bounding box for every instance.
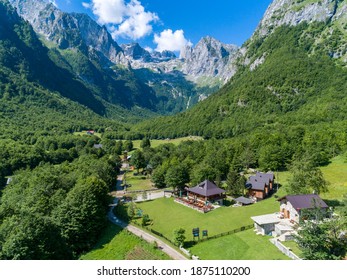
[246,172,275,200]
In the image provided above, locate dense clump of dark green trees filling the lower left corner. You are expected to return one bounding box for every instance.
[0,155,116,260]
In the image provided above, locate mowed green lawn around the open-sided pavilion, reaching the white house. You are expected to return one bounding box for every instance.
[137,198,279,241]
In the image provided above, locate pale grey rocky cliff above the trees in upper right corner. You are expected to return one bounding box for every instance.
[245,0,347,70]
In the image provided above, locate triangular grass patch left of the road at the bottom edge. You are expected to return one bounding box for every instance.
[80,223,170,260]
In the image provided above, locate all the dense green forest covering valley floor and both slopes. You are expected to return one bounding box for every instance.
[0,1,347,259]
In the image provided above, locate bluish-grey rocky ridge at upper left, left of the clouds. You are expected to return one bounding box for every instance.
[9,0,123,62]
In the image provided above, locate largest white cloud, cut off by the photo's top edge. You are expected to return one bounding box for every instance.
[87,0,159,40]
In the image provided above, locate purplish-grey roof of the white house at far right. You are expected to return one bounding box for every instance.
[278,194,328,210]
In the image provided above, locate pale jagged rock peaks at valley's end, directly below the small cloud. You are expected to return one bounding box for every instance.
[121,37,239,85]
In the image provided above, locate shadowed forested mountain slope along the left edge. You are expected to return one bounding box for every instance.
[0,1,154,139]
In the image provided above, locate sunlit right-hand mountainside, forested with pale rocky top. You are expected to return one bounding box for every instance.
[136,0,347,141]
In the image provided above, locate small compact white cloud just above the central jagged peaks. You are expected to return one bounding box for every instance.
[154,29,192,52]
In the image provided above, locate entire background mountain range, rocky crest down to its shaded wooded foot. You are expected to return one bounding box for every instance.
[9,0,238,116]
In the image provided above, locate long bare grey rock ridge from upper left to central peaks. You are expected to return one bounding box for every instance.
[9,0,238,84]
